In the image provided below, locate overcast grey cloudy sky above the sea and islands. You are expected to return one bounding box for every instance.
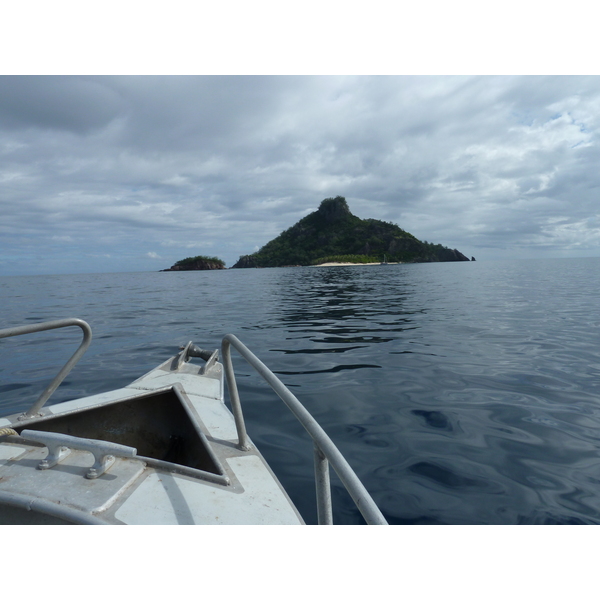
[0,76,600,275]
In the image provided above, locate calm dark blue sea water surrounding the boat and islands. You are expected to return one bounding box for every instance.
[0,259,600,524]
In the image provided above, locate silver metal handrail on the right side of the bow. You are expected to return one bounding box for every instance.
[221,334,388,525]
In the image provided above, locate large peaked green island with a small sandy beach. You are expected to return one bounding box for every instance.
[231,196,469,269]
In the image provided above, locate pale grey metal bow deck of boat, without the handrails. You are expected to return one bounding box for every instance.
[0,361,303,525]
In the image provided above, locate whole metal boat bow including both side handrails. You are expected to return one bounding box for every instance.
[0,319,387,525]
